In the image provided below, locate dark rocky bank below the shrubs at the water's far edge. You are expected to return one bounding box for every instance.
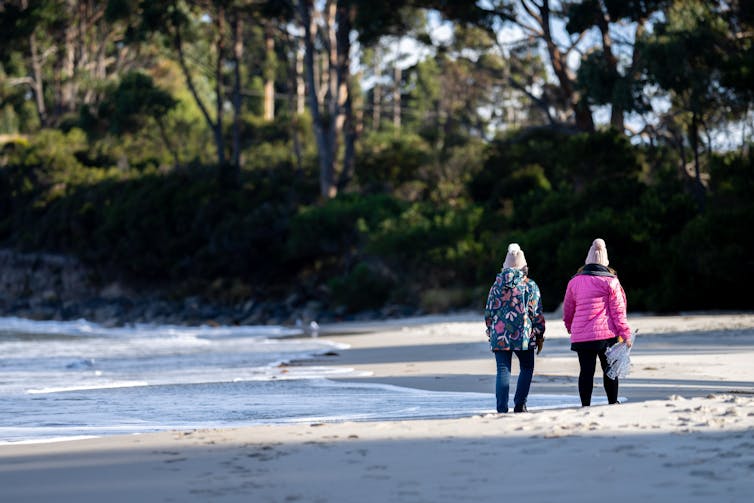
[0,249,415,326]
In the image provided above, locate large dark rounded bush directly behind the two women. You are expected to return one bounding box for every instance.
[471,132,696,310]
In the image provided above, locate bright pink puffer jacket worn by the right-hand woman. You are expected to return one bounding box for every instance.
[563,274,631,342]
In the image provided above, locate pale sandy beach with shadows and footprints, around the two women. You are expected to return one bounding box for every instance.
[0,314,754,503]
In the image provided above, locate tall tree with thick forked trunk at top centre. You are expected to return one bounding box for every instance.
[285,0,494,198]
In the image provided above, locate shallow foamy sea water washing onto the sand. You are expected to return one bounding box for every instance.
[0,318,575,444]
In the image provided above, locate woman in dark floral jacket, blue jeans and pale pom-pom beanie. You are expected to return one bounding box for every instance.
[484,243,545,412]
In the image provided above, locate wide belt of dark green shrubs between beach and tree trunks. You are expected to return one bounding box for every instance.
[0,123,754,312]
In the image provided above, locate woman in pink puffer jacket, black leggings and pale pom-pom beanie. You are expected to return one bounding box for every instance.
[563,239,632,406]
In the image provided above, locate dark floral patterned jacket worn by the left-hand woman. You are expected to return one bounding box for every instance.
[484,269,545,351]
